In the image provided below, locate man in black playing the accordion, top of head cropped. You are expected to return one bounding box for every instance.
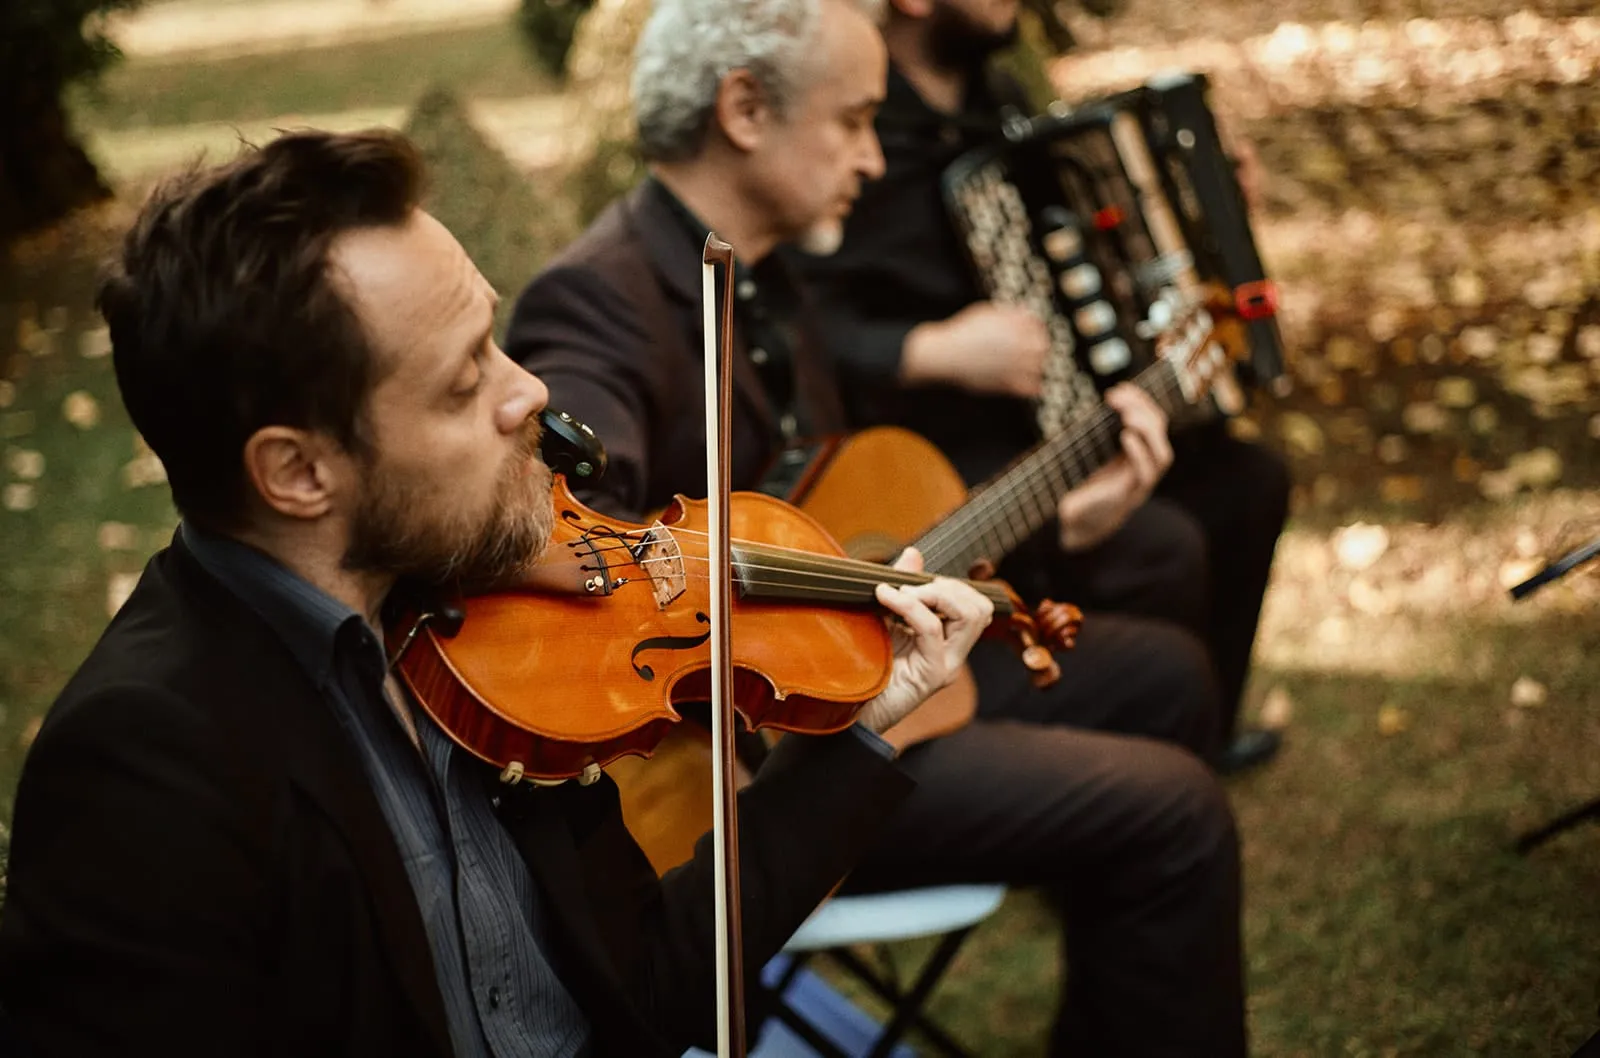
[795,0,1290,771]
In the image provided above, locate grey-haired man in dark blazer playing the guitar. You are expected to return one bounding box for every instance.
[506,0,1245,1058]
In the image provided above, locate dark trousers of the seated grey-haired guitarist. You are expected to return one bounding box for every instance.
[846,615,1245,1058]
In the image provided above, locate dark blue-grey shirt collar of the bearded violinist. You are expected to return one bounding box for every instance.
[178,522,382,687]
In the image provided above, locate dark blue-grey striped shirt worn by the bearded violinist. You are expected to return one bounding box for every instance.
[182,523,590,1058]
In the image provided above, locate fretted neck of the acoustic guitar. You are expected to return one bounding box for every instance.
[912,359,1187,576]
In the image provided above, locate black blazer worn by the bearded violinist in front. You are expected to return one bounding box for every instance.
[0,541,910,1058]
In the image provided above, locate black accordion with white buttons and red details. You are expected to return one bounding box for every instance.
[942,74,1288,437]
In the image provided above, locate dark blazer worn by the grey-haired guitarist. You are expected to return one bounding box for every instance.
[506,181,845,515]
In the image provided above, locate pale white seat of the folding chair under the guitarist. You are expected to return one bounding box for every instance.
[784,885,1005,951]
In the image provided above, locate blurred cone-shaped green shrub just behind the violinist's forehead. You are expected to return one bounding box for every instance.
[405,88,579,327]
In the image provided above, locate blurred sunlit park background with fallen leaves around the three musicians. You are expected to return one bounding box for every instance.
[0,0,1600,1056]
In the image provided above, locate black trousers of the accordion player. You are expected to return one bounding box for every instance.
[1002,423,1290,746]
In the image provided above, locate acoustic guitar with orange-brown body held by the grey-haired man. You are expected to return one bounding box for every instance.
[606,300,1229,872]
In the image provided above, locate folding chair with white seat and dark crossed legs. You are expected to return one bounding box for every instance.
[771,885,1005,1058]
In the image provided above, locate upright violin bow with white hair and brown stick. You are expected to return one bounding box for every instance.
[701,232,744,1058]
